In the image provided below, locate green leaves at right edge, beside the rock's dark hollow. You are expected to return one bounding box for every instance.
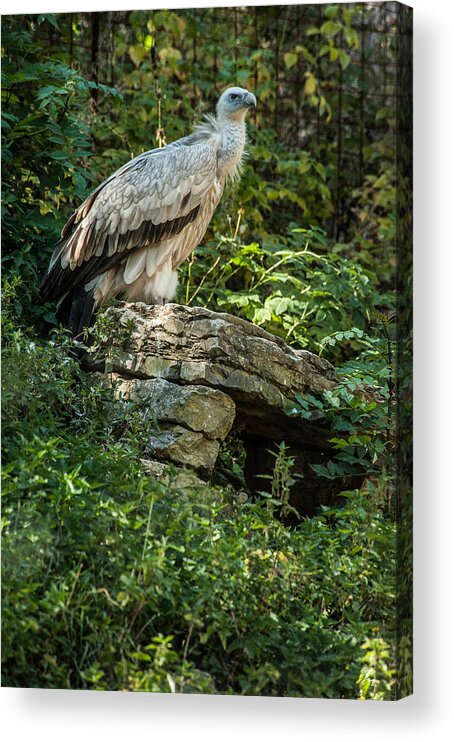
[287,313,395,512]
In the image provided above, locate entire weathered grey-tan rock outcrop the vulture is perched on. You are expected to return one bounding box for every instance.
[86,303,354,514]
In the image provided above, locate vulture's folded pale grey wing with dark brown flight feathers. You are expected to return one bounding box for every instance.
[41,141,217,298]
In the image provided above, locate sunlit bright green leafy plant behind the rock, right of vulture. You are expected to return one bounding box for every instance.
[180,224,393,361]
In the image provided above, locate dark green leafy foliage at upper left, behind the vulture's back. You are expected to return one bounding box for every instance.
[2,16,118,321]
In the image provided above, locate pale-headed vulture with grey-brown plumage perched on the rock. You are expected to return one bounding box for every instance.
[40,87,257,336]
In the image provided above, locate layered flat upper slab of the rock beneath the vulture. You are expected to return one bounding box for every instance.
[93,303,336,446]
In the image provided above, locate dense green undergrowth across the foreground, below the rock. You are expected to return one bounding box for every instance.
[2,332,394,698]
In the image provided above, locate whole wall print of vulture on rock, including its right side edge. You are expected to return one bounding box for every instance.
[2,2,412,700]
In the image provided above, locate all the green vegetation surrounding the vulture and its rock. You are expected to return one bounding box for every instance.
[2,5,411,699]
